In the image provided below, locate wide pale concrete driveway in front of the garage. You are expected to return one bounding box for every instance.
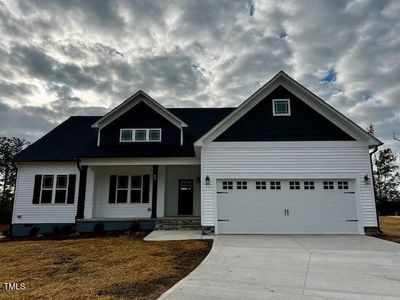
[160,235,400,300]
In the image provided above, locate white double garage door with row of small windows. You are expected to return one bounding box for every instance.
[217,179,359,234]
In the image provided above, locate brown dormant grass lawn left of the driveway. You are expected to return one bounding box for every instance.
[0,236,211,299]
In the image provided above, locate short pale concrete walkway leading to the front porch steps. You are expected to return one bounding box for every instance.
[144,230,214,241]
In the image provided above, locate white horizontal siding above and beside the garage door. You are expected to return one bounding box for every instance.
[201,142,377,227]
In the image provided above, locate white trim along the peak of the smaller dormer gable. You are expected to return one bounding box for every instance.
[92,91,188,128]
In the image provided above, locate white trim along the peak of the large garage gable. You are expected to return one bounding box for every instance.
[194,71,382,146]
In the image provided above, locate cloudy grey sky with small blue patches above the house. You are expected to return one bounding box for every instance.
[0,0,400,153]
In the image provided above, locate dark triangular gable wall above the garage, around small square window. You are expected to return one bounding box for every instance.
[214,86,354,142]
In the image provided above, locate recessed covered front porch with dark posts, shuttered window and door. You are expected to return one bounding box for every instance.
[77,164,200,224]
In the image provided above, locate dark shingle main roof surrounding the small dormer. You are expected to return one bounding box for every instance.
[15,108,234,162]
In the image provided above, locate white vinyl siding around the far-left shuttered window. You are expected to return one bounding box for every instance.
[12,163,79,224]
